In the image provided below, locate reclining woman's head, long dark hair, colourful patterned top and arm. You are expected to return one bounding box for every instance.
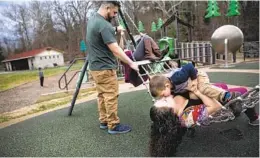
[149,84,222,157]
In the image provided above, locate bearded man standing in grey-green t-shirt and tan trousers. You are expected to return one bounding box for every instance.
[87,1,139,134]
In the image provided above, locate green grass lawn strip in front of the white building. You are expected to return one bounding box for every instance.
[0,61,83,91]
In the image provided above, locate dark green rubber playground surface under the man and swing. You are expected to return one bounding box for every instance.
[0,62,259,157]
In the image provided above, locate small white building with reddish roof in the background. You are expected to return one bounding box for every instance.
[2,47,64,71]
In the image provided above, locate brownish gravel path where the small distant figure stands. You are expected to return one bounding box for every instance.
[0,71,92,114]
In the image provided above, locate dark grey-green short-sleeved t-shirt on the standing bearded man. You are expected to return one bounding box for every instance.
[87,13,117,71]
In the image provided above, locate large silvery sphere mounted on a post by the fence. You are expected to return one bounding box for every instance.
[211,25,244,67]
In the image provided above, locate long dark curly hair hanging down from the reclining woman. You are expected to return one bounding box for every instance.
[149,106,187,157]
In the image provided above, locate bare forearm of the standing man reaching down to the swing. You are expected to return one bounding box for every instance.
[107,42,139,71]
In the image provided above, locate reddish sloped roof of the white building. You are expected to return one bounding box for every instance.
[2,47,61,62]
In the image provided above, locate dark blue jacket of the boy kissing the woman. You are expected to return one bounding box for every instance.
[169,63,197,93]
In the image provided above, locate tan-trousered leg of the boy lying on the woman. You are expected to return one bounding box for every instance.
[197,70,226,102]
